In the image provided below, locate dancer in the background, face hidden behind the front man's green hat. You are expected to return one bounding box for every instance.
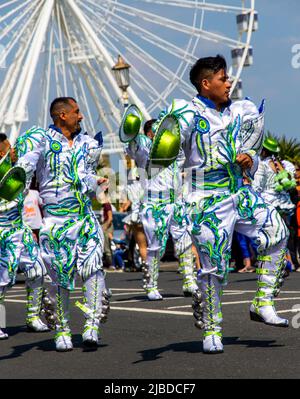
[126,119,197,301]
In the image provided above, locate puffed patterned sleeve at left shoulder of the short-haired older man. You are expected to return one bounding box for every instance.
[15,126,46,189]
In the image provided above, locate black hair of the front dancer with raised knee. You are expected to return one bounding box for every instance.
[190,54,227,94]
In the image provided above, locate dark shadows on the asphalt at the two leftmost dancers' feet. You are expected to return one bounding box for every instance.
[0,327,107,361]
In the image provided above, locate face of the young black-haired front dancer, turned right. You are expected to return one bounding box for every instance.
[202,69,231,105]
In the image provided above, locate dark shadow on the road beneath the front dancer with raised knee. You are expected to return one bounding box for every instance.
[133,337,284,364]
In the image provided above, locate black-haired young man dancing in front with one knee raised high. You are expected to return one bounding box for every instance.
[151,55,288,353]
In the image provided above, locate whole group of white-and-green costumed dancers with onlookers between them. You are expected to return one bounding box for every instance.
[0,55,300,353]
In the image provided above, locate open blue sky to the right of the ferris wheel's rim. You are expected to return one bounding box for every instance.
[242,0,300,140]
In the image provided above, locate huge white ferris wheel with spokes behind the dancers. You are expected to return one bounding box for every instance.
[0,0,257,153]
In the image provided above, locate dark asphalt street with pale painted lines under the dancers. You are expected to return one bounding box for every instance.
[0,263,300,379]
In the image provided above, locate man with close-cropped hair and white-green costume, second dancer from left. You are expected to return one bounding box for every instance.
[17,97,108,351]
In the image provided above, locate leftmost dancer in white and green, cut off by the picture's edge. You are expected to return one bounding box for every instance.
[0,133,49,339]
